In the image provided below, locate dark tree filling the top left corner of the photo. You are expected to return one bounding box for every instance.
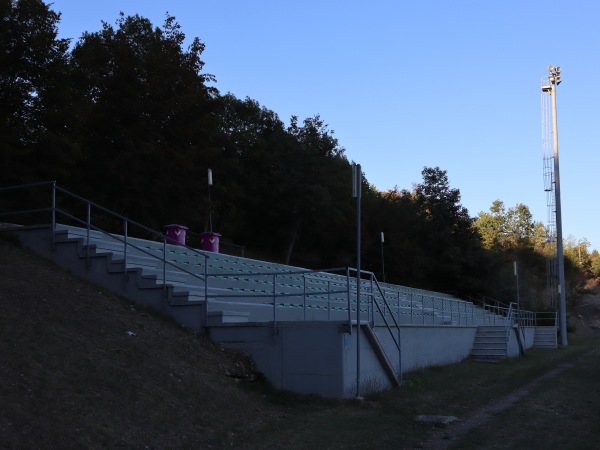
[0,0,73,183]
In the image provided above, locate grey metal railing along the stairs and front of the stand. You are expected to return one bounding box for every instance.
[0,181,548,336]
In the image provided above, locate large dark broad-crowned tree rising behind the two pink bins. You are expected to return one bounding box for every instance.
[71,14,222,226]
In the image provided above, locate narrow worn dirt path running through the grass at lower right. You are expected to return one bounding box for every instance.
[423,364,573,450]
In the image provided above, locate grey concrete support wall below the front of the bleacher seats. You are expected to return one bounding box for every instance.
[210,321,476,398]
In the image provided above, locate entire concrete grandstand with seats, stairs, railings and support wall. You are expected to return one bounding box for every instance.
[0,183,556,398]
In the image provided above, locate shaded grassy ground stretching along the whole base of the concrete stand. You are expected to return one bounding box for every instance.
[0,240,600,449]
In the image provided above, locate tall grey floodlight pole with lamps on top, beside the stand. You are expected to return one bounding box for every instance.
[542,66,568,346]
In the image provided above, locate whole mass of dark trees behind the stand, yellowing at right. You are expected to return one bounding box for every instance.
[0,0,600,306]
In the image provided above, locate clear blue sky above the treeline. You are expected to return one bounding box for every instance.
[52,0,600,250]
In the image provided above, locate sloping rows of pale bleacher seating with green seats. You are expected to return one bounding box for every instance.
[56,224,506,325]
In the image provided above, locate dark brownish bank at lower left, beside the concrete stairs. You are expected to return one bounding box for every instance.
[0,240,278,448]
